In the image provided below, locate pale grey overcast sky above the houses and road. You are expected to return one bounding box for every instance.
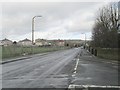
[1,2,108,41]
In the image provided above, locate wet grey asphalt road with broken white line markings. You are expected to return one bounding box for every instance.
[2,48,118,88]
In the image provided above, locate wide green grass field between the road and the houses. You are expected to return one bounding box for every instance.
[0,46,68,59]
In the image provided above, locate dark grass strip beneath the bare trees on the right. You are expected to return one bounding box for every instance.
[97,48,120,60]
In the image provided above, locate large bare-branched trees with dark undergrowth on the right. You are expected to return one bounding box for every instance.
[92,3,118,48]
